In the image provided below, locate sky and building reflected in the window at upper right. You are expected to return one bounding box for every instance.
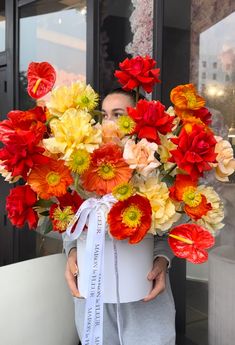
[198,12,235,127]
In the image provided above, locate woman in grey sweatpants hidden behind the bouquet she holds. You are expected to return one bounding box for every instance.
[64,89,175,345]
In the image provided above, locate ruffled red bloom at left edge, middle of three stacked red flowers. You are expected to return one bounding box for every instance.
[0,131,49,180]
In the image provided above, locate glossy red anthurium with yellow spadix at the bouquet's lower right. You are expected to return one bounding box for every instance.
[168,224,215,264]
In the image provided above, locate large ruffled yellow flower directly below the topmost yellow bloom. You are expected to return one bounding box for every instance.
[43,109,102,161]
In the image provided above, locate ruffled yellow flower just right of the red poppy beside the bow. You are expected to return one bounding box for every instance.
[137,177,181,234]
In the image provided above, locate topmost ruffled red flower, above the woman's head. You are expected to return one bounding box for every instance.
[114,56,160,93]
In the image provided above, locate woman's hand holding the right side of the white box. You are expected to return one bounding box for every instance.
[144,256,168,302]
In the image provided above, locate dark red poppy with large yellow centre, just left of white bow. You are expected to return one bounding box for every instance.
[50,191,83,232]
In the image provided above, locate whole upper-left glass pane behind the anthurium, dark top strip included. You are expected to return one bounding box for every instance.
[19,0,86,109]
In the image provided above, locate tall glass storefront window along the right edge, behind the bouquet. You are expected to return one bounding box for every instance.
[186,0,235,345]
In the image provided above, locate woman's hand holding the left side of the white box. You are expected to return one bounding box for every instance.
[65,248,81,297]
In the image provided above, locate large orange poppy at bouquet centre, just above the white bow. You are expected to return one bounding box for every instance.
[81,143,132,195]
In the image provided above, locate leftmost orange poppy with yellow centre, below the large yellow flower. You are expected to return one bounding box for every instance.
[27,158,73,199]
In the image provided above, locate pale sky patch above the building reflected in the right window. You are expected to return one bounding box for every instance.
[200,12,235,55]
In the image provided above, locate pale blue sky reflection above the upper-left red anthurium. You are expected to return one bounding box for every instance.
[20,9,86,74]
